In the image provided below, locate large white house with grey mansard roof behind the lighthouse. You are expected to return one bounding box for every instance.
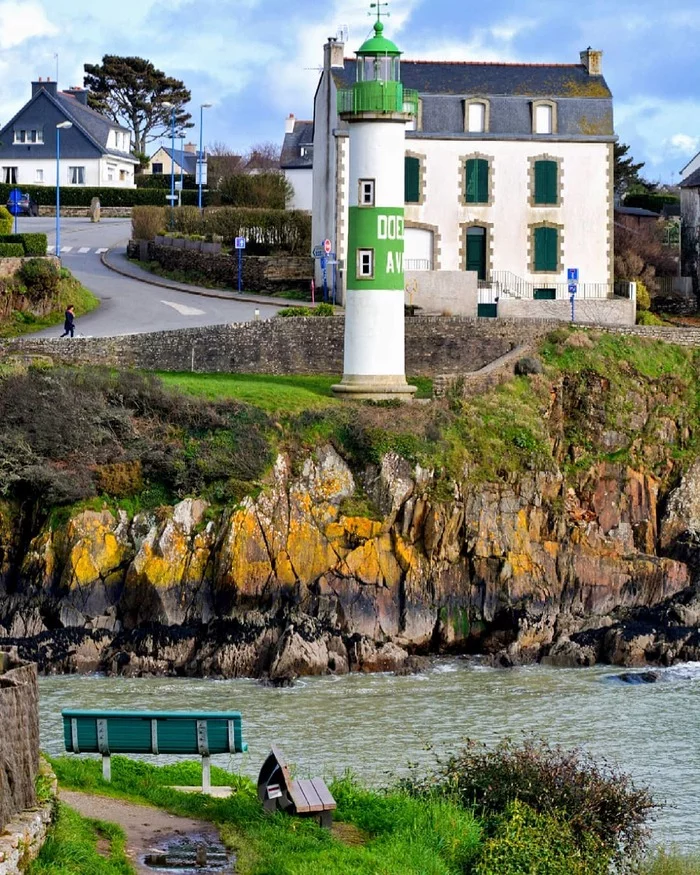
[312,39,633,321]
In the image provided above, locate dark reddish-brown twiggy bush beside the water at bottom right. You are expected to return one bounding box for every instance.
[410,739,656,872]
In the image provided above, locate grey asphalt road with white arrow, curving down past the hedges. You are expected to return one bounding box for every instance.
[18,217,279,337]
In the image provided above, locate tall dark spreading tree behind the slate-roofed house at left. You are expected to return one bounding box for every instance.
[83,55,192,153]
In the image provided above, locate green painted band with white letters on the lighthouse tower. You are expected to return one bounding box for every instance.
[347,207,404,290]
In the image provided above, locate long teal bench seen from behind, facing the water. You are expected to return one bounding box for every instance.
[61,709,248,793]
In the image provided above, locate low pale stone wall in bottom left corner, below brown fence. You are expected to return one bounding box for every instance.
[0,759,58,875]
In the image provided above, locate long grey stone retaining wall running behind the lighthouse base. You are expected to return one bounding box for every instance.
[0,316,700,377]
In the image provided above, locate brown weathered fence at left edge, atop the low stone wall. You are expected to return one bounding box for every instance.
[0,651,39,830]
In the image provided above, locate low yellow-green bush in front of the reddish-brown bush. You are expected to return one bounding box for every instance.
[473,801,609,875]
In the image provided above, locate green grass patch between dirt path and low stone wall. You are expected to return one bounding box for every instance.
[27,803,134,875]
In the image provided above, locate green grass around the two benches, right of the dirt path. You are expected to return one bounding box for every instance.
[49,757,480,875]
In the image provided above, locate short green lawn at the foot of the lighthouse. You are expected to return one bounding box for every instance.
[158,372,433,414]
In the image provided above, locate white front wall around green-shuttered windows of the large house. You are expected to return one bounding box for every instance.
[406,138,612,283]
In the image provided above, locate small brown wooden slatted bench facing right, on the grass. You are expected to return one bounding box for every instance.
[258,745,336,829]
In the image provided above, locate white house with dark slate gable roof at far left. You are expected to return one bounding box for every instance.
[0,79,139,188]
